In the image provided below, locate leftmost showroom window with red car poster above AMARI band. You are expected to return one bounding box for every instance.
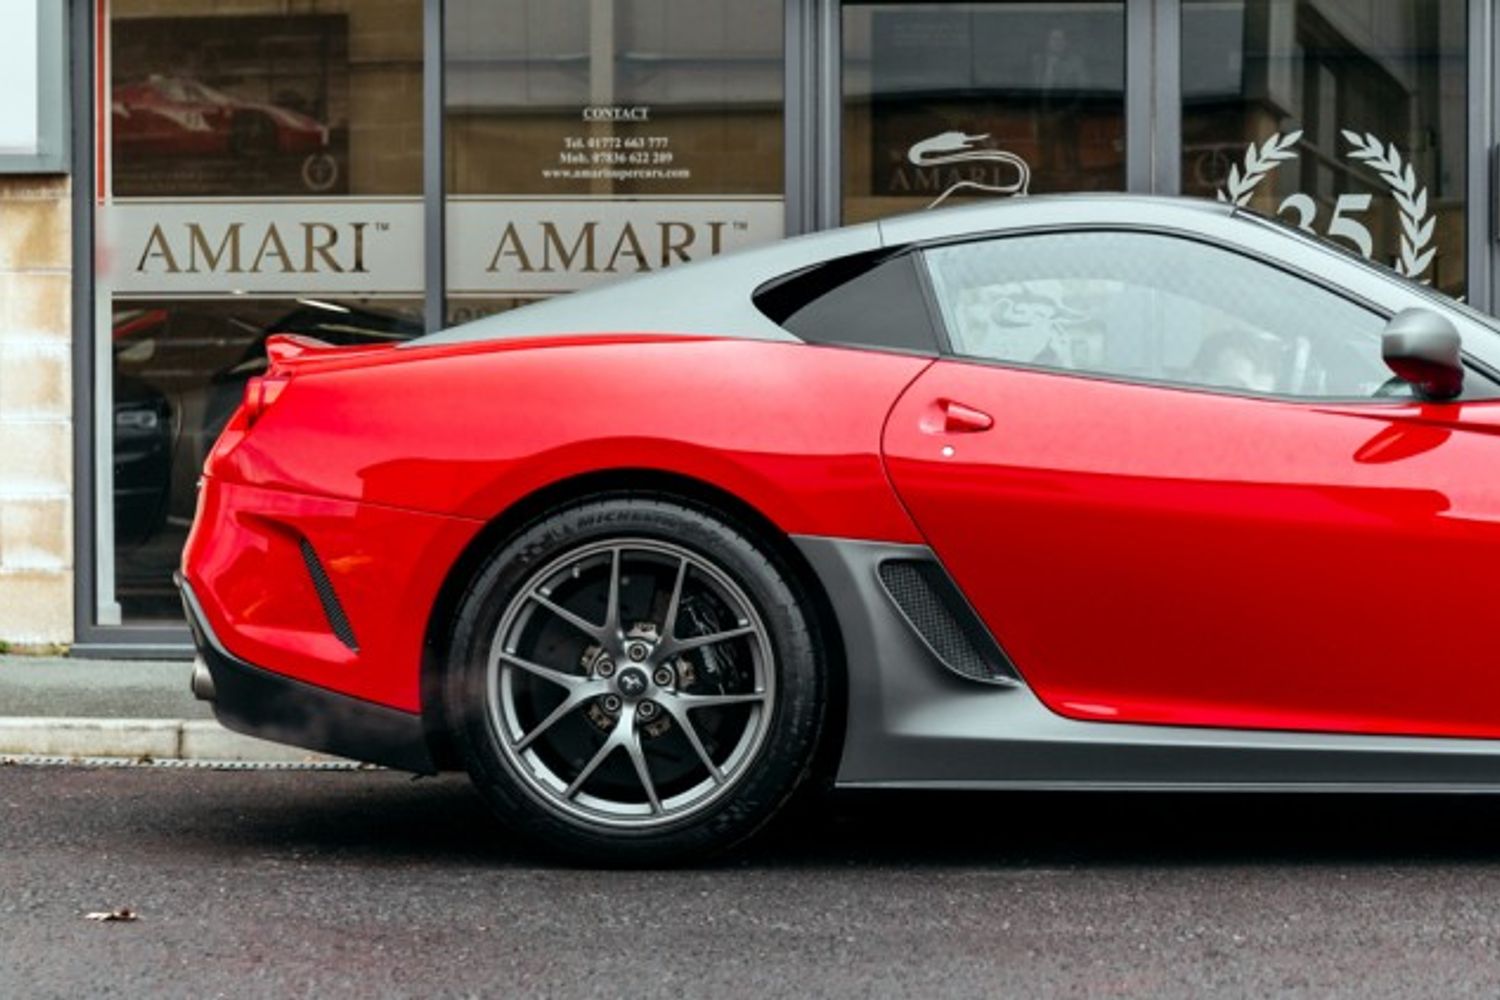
[95,0,423,624]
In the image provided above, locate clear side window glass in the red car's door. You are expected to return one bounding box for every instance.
[924,231,1391,399]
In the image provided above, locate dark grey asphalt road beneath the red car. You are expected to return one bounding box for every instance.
[0,766,1500,1000]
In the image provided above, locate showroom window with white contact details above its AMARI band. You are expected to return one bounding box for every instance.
[444,0,786,322]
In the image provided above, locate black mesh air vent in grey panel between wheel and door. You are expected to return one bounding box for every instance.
[879,559,1020,685]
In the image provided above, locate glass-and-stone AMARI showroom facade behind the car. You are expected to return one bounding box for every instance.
[0,0,1500,654]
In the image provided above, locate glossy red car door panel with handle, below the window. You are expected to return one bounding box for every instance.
[884,361,1500,736]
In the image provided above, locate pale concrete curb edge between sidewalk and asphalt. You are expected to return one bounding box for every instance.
[0,718,344,763]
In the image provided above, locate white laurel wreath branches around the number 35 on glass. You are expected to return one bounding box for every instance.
[1218,129,1437,279]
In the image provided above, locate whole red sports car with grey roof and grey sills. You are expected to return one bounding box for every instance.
[182,196,1500,864]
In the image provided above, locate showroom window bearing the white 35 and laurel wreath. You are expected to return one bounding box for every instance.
[1182,0,1470,295]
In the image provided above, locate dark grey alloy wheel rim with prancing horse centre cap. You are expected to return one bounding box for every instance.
[486,538,776,829]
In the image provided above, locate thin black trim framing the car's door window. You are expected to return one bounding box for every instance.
[900,222,1500,406]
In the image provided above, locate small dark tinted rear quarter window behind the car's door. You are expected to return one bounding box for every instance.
[756,250,938,354]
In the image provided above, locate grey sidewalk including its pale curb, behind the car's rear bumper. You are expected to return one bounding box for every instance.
[0,655,349,763]
